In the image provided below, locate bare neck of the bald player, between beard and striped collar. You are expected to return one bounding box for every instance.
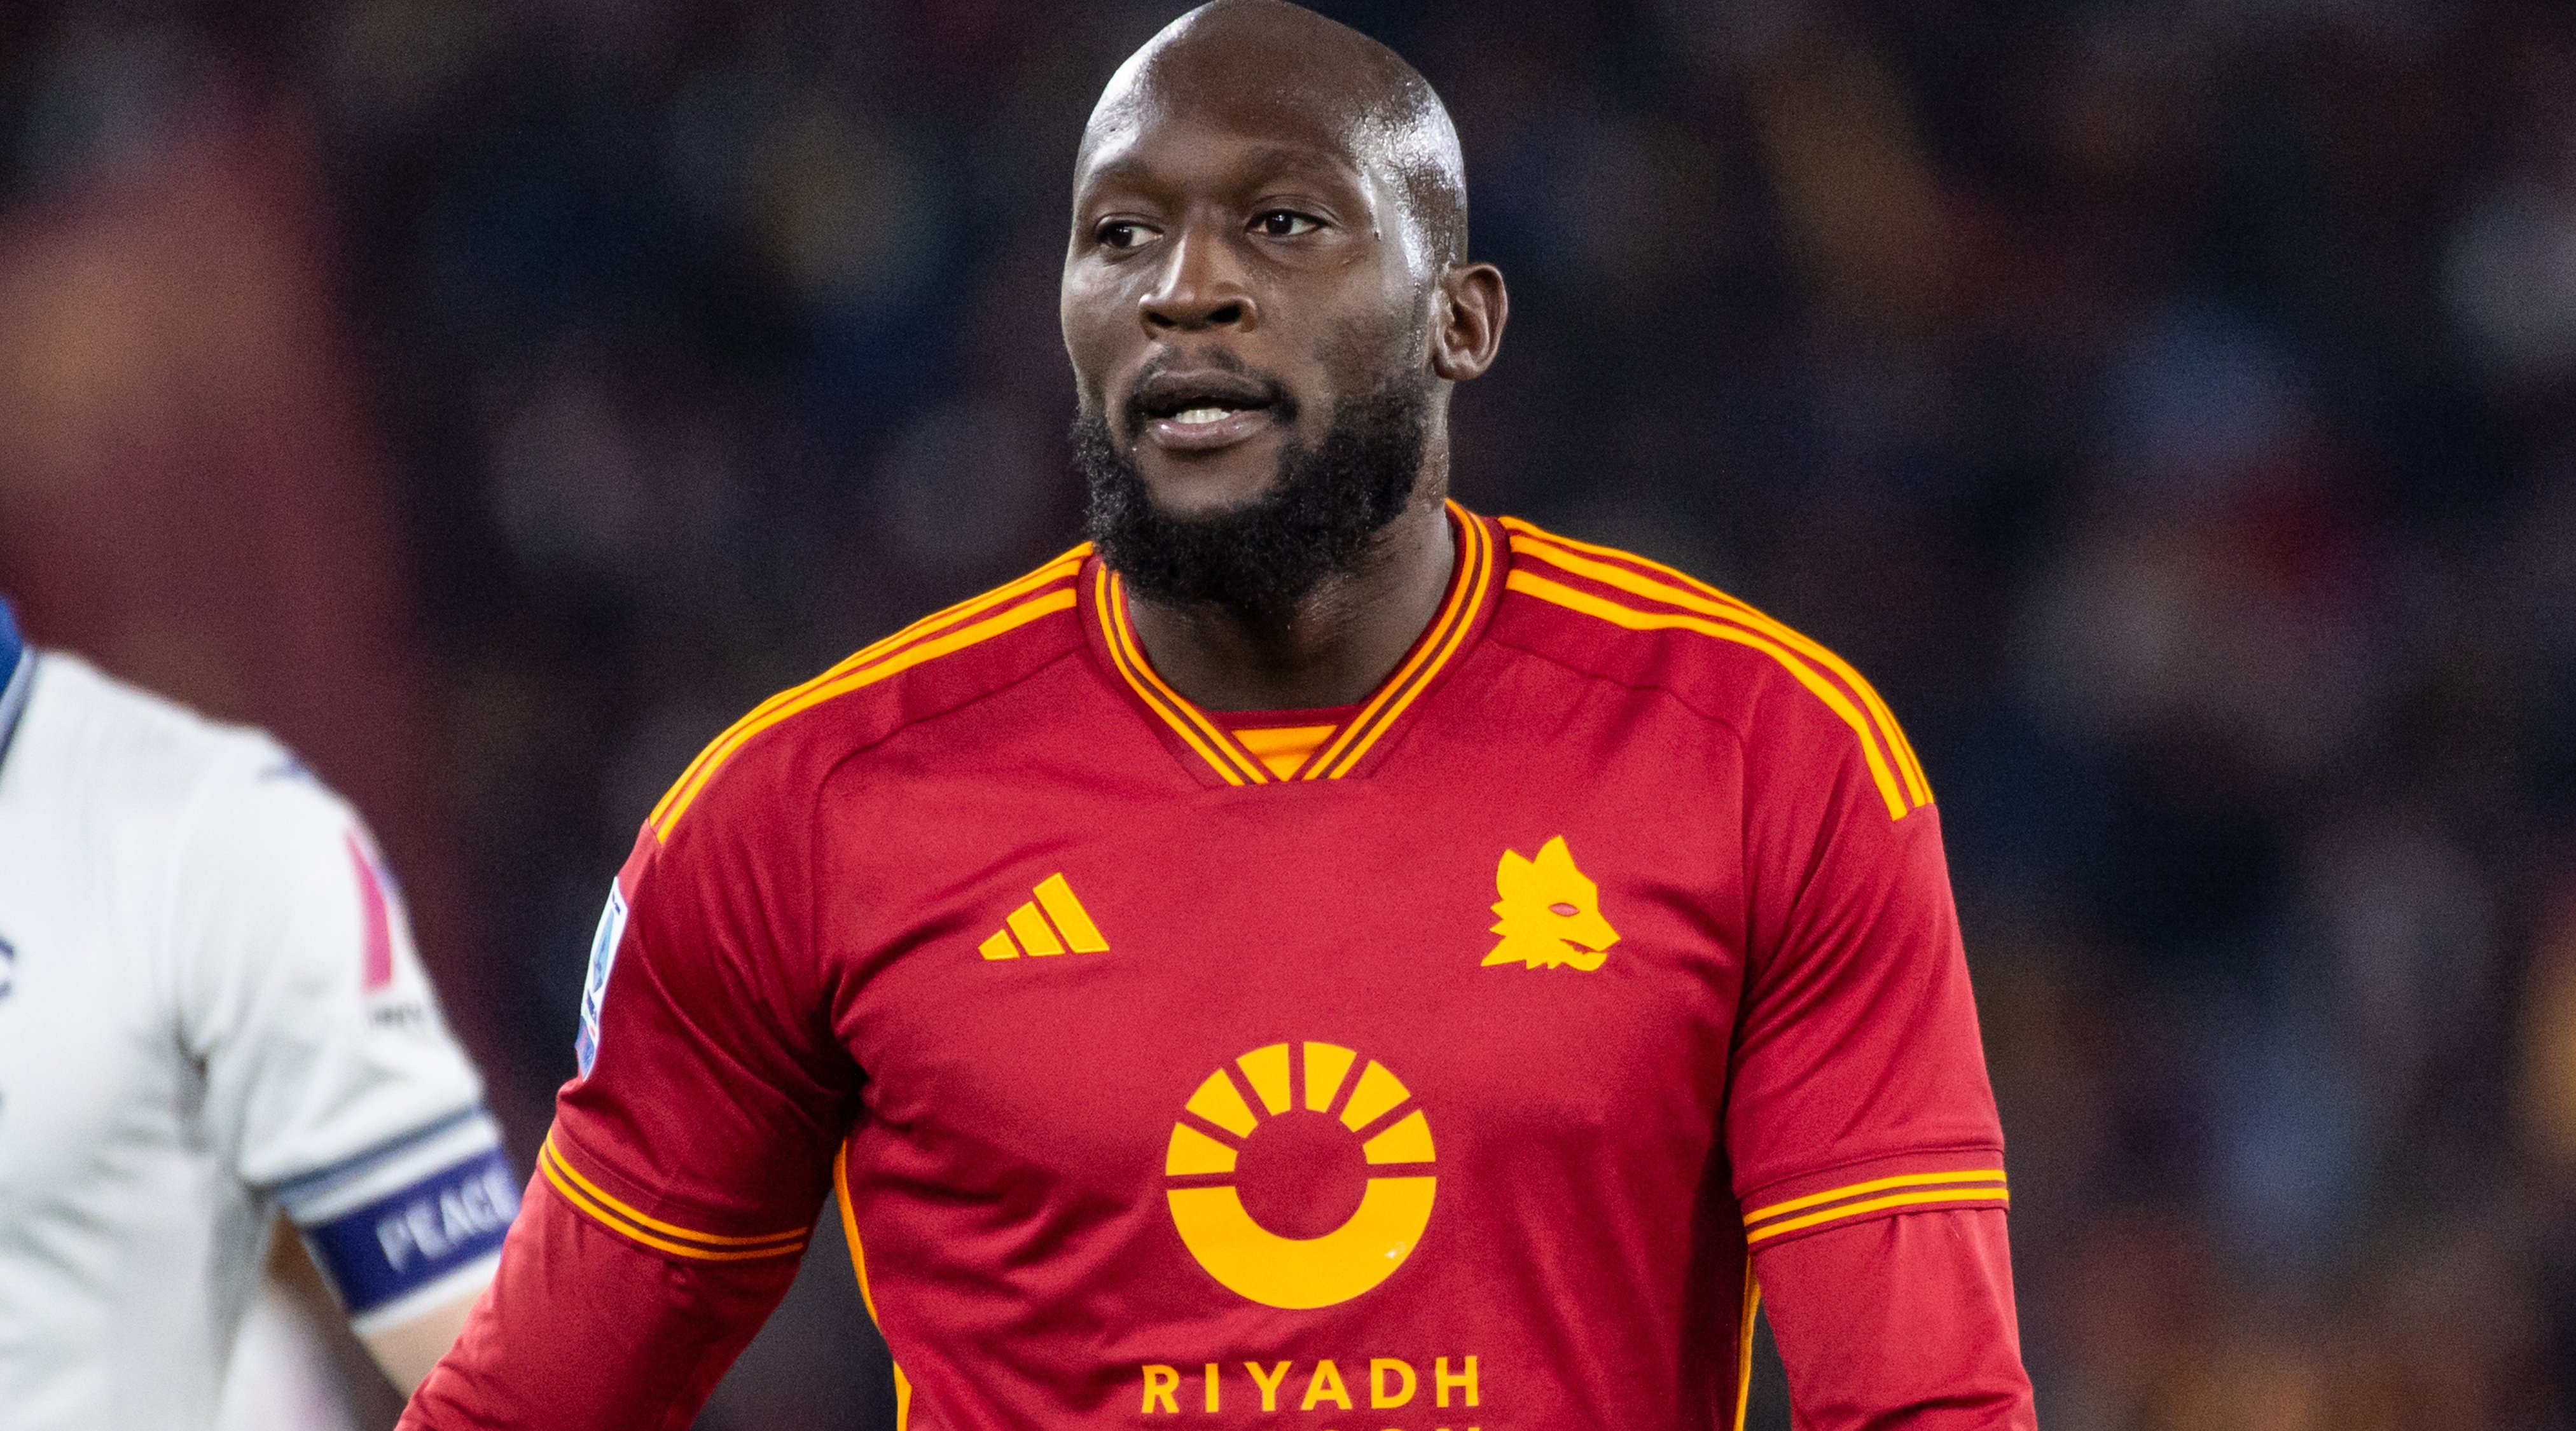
[1128,481,1458,710]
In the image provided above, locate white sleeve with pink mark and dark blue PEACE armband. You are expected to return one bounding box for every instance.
[167,741,518,1331]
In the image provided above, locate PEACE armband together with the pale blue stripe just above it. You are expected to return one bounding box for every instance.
[278,1109,518,1333]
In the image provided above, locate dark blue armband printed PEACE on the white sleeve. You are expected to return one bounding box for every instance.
[304,1148,518,1315]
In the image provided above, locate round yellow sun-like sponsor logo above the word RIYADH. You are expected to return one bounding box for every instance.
[1162,1042,1437,1310]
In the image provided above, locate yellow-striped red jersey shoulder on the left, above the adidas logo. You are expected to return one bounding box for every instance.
[644,543,1092,841]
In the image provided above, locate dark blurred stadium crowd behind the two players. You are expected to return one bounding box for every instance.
[0,0,2576,1431]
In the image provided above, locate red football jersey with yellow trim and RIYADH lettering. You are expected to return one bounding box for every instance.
[407,507,2027,1431]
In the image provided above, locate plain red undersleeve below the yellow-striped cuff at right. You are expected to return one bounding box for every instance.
[1754,1210,2038,1431]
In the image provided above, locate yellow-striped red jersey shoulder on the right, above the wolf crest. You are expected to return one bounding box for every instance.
[1494,517,1932,819]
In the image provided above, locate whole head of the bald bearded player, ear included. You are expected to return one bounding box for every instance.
[1059,0,1507,644]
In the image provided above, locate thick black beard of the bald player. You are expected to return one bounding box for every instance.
[1074,378,1432,620]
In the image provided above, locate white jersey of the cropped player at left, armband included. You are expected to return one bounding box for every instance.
[0,648,518,1431]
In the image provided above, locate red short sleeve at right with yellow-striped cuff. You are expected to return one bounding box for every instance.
[1726,674,2007,1248]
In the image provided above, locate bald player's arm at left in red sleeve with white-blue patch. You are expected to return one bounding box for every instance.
[402,790,858,1431]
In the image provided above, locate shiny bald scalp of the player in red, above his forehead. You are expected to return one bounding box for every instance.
[1074,0,1465,275]
